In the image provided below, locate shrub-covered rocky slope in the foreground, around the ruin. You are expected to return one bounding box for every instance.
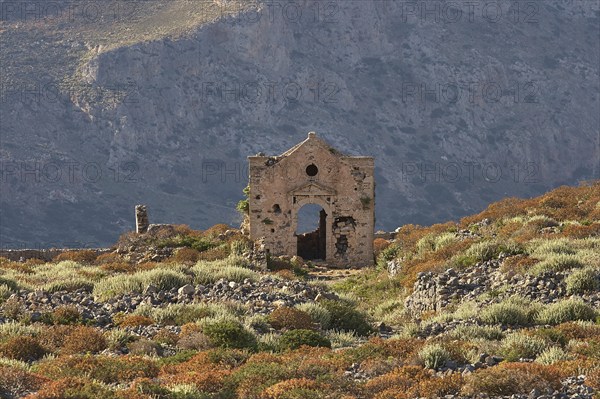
[0,181,600,399]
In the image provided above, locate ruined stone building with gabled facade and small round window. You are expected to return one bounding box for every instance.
[248,132,375,267]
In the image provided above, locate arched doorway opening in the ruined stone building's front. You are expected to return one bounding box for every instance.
[296,204,327,260]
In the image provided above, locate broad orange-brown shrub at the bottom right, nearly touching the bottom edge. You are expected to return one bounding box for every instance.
[462,363,561,395]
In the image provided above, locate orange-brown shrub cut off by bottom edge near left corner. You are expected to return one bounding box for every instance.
[26,377,116,399]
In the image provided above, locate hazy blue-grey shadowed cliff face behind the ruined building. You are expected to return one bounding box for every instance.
[0,1,600,247]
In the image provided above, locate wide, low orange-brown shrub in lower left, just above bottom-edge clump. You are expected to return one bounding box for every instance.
[37,355,159,384]
